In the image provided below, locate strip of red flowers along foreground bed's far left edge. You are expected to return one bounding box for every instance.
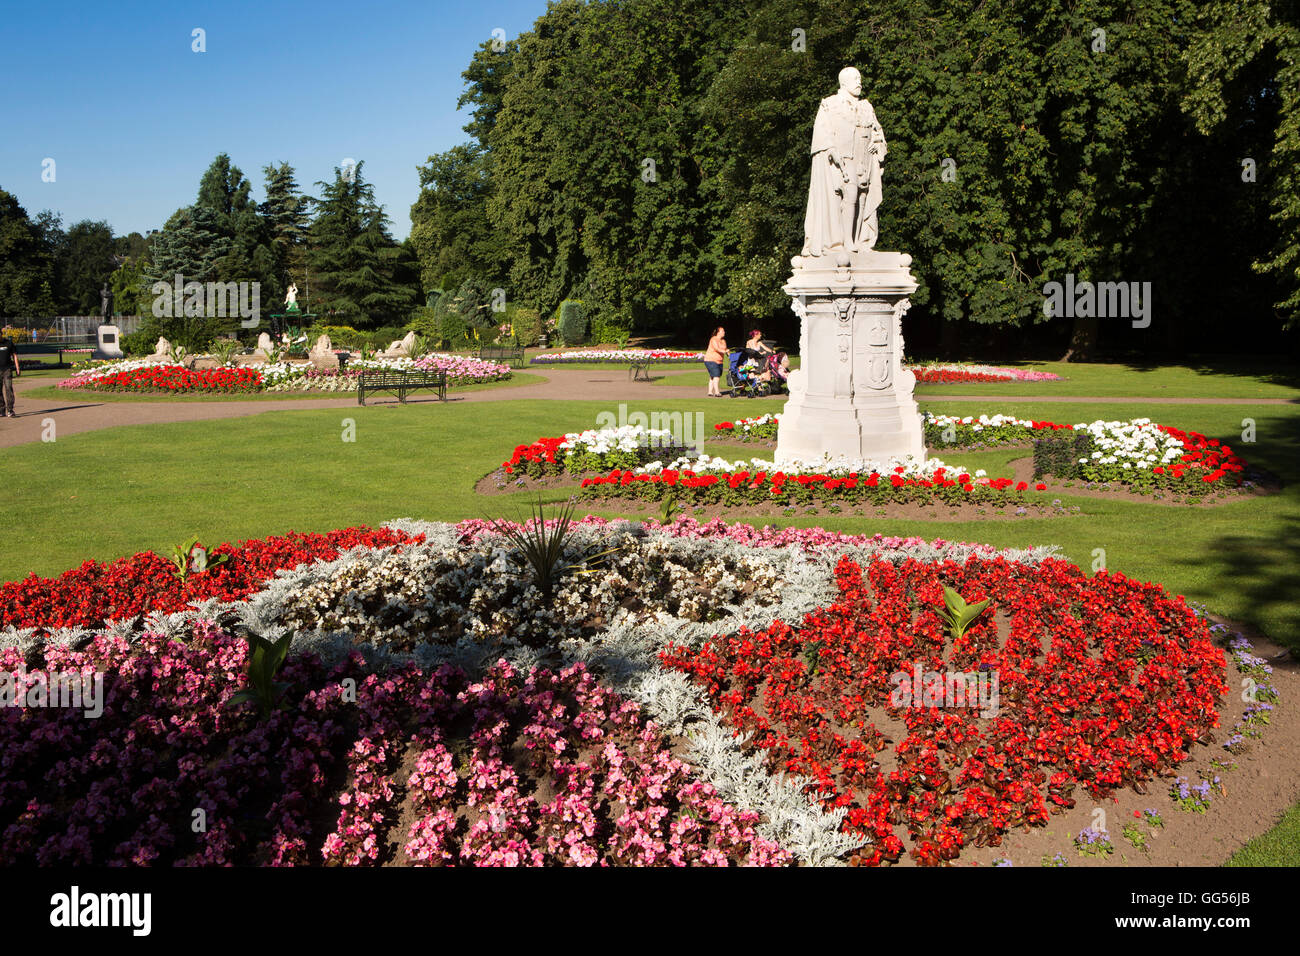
[0,527,423,628]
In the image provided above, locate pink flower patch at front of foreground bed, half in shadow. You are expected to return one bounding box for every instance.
[0,623,789,866]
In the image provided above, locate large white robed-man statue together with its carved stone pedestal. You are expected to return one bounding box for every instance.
[776,66,926,464]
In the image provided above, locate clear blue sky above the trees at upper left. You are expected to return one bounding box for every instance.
[0,0,546,238]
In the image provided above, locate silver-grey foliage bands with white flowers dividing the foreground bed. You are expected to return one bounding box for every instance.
[0,519,1060,866]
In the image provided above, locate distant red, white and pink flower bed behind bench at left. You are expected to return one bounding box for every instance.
[59,354,512,394]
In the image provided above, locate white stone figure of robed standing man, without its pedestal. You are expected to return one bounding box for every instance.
[803,66,885,263]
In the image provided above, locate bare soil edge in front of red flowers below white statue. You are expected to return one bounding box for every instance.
[475,468,1079,522]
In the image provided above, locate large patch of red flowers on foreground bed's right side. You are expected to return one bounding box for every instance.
[660,558,1227,865]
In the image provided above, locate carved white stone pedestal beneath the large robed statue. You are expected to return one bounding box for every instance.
[776,250,926,464]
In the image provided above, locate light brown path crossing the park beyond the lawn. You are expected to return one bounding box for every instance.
[0,365,1300,447]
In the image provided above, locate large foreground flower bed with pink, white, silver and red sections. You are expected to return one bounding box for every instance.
[0,518,1226,865]
